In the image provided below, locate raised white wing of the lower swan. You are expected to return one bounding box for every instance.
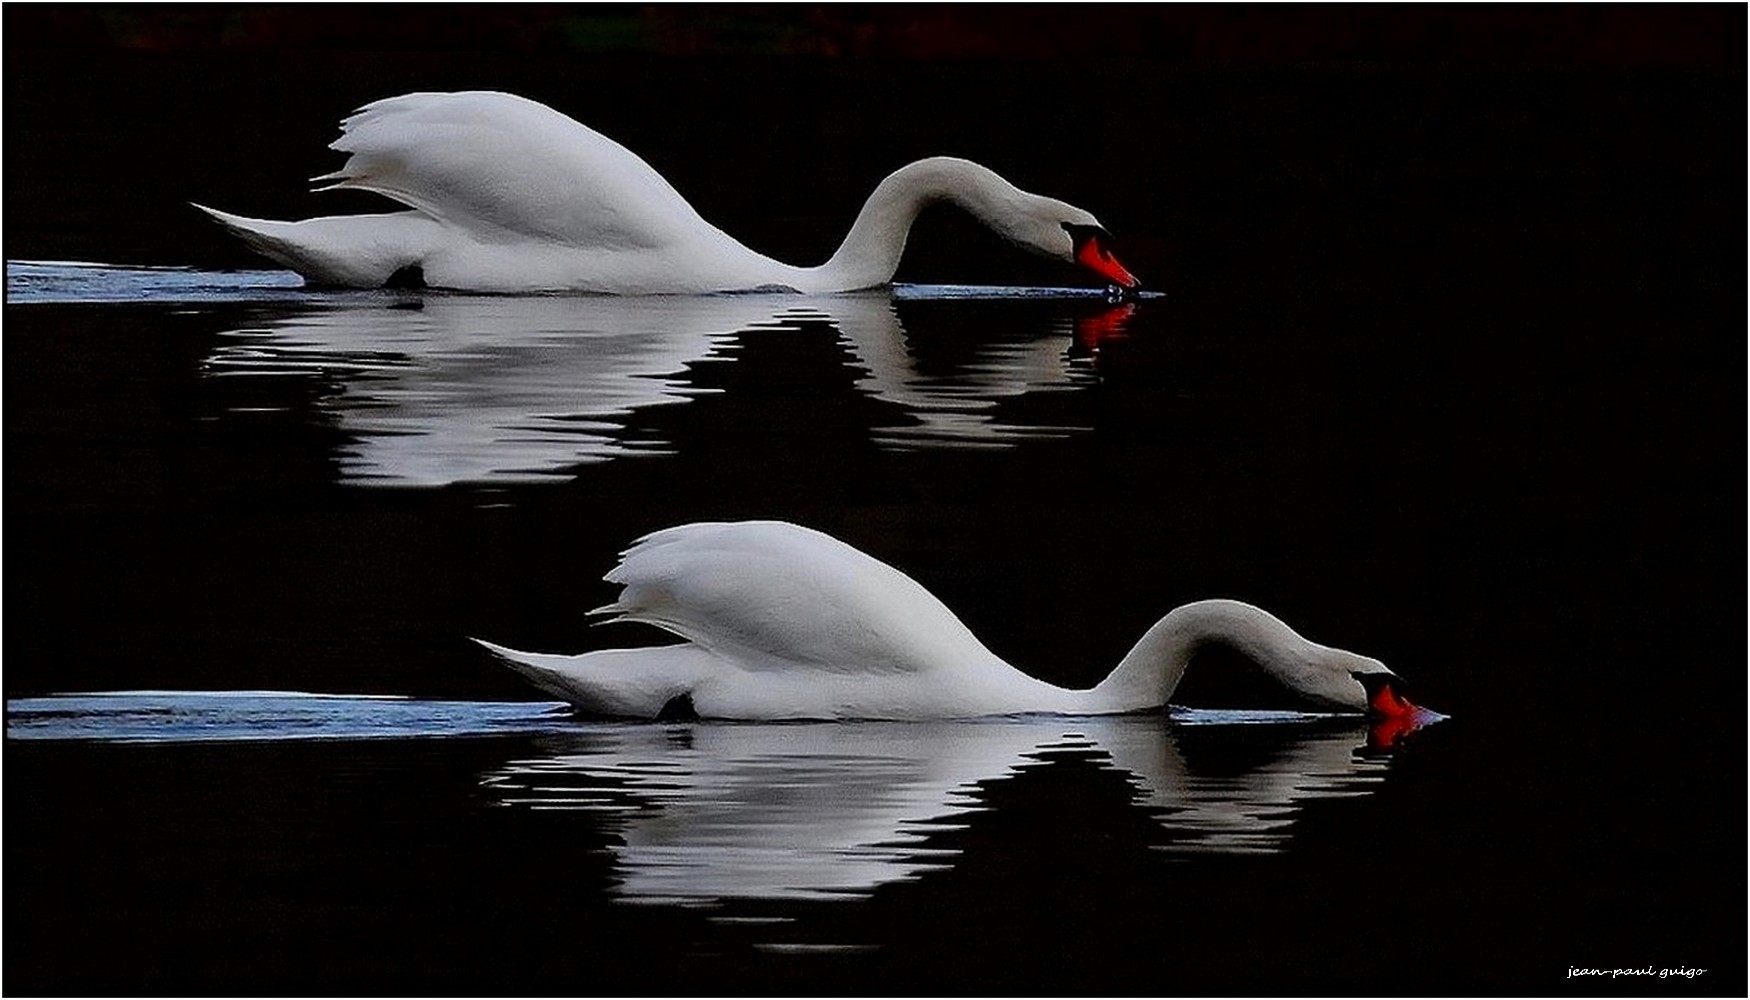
[597,522,996,673]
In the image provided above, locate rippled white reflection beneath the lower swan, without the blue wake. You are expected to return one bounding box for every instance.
[483,709,1388,904]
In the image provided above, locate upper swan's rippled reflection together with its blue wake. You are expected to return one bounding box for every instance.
[7,261,1138,487]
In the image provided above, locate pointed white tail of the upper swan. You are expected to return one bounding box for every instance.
[194,205,439,289]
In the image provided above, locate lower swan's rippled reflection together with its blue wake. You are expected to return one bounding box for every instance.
[5,692,1390,904]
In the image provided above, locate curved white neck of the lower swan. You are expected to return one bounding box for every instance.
[1087,601,1365,711]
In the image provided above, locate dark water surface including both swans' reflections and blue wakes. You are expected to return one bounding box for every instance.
[4,45,1745,995]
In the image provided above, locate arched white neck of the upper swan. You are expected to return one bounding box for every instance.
[796,156,1041,292]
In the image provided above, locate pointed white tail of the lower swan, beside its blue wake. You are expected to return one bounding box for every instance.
[474,639,712,718]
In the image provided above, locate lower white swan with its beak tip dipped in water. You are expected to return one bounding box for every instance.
[474,520,1439,725]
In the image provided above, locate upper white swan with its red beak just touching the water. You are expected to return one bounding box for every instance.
[194,91,1139,294]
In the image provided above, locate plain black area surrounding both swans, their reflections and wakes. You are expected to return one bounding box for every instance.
[5,7,1745,995]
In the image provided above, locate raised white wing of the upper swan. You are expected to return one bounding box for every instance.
[317,91,711,249]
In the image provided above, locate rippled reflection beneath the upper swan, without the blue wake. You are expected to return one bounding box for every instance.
[205,291,1136,485]
